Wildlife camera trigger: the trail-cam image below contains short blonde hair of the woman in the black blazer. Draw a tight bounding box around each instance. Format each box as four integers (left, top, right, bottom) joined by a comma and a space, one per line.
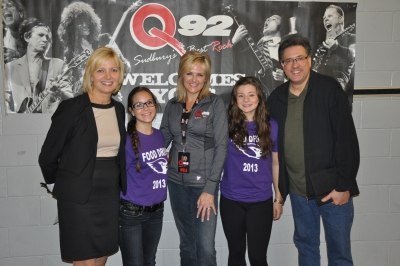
83, 47, 125, 94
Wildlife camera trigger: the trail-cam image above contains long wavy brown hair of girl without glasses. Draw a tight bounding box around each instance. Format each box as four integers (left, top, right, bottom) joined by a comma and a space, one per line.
228, 77, 272, 158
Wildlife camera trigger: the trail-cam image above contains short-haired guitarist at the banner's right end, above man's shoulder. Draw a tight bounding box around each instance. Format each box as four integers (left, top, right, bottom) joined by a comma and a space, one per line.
313, 5, 356, 97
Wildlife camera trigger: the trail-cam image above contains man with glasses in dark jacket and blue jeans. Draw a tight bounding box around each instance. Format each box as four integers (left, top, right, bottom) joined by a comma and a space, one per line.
267, 35, 360, 266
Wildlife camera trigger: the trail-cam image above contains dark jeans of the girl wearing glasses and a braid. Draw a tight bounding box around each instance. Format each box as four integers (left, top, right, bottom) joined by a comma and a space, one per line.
119, 204, 164, 266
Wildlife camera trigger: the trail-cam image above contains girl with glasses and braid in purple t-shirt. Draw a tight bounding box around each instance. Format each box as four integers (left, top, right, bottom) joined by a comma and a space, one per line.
119, 87, 168, 265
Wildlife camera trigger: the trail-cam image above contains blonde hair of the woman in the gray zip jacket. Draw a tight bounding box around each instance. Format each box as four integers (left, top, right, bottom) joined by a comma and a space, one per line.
176, 51, 211, 102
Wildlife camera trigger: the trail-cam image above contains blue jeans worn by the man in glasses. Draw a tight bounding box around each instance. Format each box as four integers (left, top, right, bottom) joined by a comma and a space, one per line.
290, 193, 354, 266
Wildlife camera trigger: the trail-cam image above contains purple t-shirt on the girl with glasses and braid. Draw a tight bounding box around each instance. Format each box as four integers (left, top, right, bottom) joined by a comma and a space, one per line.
121, 128, 168, 206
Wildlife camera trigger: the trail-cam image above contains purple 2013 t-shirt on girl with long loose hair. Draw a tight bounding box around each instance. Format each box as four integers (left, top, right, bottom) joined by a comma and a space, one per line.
221, 118, 278, 202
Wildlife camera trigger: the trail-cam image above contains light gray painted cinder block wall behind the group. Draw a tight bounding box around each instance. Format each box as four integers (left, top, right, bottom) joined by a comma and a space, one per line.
0, 0, 400, 266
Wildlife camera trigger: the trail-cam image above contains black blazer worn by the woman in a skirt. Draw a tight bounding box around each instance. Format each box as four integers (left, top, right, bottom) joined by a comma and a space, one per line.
39, 93, 126, 204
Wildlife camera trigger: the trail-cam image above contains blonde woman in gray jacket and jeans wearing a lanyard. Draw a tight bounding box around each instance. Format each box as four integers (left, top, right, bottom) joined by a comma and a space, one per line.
160, 51, 228, 266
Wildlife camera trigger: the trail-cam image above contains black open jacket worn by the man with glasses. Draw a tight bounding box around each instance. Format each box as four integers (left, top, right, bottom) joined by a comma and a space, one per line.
267, 71, 360, 199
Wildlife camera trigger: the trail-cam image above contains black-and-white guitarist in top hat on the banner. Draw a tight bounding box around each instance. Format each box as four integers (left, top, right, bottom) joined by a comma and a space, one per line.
232, 15, 285, 97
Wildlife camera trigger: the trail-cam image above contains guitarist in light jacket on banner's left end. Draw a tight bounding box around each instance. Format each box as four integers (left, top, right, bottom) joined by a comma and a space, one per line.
5, 18, 73, 113
